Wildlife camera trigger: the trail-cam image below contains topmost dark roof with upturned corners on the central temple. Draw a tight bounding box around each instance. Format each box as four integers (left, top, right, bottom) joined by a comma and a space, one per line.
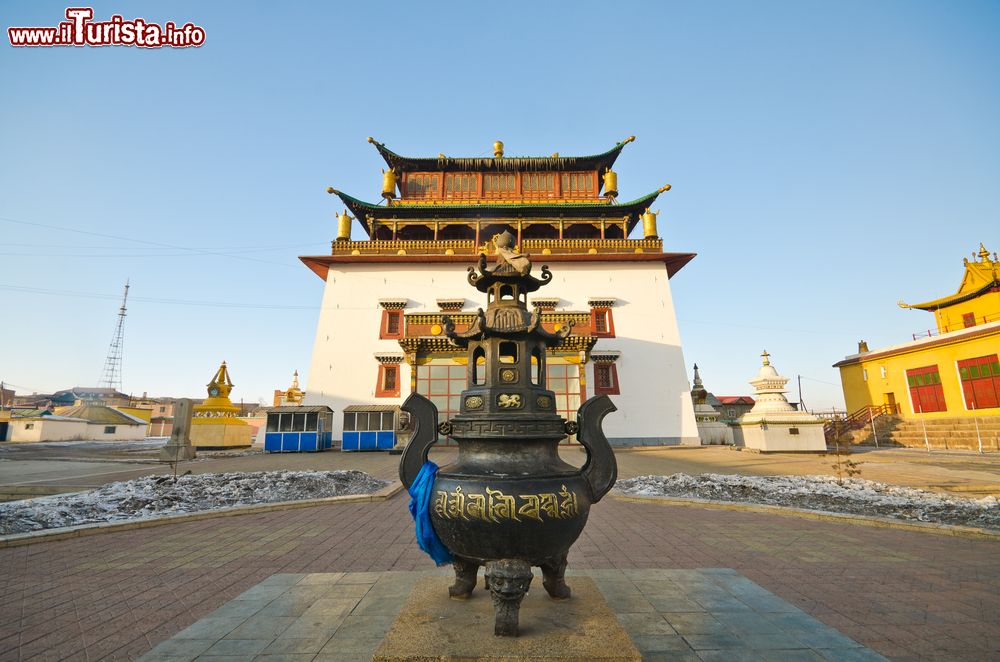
368, 136, 635, 172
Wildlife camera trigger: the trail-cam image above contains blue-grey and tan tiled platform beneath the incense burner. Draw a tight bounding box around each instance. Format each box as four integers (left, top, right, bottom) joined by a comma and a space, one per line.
140, 568, 885, 662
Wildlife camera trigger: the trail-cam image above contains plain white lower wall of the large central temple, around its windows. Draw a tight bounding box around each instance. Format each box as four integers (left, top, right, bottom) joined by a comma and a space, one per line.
305, 256, 699, 445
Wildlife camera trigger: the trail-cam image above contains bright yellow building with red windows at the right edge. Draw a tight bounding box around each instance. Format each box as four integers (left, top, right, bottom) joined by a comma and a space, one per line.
834, 244, 1000, 419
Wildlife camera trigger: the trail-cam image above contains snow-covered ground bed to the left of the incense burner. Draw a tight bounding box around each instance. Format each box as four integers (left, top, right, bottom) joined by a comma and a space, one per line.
0, 471, 389, 535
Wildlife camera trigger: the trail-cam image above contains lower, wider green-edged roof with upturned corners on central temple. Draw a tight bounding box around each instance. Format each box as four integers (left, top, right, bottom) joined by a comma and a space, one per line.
329, 186, 668, 234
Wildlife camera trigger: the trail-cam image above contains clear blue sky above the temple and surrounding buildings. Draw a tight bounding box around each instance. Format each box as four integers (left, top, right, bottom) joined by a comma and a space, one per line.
0, 0, 1000, 407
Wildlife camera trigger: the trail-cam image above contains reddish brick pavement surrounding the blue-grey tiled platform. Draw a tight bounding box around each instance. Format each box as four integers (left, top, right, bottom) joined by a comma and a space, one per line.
0, 494, 1000, 660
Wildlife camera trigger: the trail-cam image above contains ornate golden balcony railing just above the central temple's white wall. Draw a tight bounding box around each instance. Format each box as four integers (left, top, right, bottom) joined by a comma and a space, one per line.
332, 239, 663, 255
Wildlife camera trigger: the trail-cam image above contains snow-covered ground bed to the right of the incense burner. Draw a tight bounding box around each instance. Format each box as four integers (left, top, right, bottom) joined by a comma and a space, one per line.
616, 474, 1000, 529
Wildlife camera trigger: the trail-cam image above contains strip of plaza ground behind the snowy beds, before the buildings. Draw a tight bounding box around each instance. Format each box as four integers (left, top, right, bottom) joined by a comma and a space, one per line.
0, 444, 1000, 498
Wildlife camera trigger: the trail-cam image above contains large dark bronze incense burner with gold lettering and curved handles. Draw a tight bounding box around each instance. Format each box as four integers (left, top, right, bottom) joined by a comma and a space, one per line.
399, 233, 617, 636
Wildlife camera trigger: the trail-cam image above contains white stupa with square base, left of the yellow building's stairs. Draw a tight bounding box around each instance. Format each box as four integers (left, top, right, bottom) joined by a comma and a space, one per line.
737, 350, 826, 452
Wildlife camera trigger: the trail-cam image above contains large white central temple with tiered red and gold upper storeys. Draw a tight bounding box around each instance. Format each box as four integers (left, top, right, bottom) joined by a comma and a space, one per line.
301, 137, 699, 445
